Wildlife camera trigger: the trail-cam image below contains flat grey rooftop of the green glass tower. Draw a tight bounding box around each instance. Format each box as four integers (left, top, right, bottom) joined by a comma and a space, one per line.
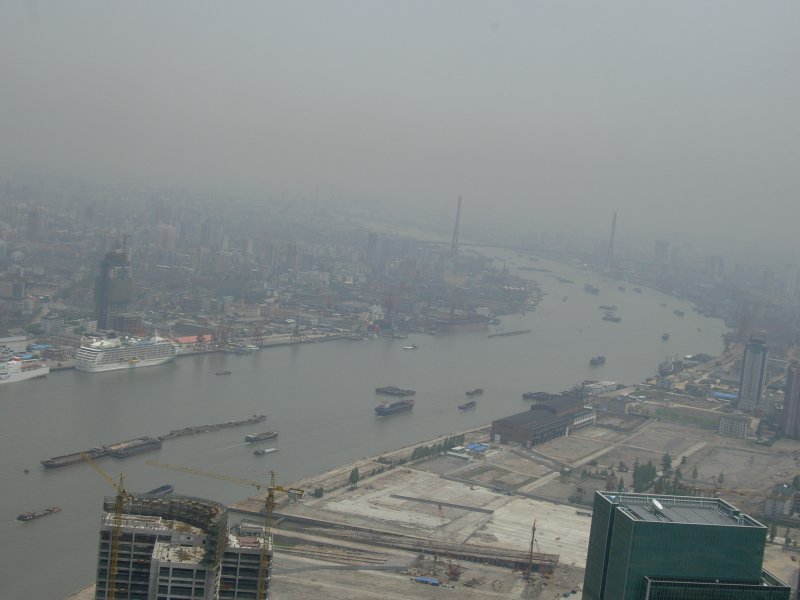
598, 492, 764, 528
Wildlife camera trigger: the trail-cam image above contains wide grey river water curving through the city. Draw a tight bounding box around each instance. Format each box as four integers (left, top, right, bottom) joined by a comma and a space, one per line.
0, 253, 725, 599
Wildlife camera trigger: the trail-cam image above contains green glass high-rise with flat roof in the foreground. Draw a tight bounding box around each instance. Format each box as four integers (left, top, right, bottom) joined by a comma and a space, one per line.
583, 491, 791, 600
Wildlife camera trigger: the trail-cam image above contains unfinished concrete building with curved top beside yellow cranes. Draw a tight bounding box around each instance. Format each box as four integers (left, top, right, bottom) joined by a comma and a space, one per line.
95, 494, 272, 600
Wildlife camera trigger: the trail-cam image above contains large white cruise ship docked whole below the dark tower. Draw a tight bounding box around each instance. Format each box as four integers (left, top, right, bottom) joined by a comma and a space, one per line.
75, 335, 179, 373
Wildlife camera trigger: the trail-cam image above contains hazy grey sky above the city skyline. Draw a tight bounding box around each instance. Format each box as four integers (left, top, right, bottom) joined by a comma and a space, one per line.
0, 0, 800, 248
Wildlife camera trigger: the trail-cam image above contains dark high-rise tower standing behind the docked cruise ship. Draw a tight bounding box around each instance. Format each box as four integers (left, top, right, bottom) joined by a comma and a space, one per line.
94, 242, 133, 329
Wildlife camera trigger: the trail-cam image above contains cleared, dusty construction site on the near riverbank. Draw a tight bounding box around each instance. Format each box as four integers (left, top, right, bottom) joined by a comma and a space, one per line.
65, 394, 800, 600
